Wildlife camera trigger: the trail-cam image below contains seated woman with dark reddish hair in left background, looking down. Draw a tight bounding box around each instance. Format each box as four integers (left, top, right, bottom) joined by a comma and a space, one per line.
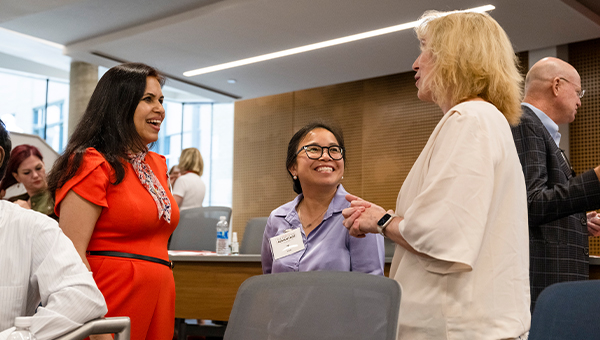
0, 144, 58, 219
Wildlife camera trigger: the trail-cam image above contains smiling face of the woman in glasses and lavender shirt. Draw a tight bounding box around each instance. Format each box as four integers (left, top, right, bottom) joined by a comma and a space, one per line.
288, 128, 344, 193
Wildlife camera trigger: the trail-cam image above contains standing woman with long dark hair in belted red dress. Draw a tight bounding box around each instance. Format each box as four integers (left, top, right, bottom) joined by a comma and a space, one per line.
49, 63, 179, 340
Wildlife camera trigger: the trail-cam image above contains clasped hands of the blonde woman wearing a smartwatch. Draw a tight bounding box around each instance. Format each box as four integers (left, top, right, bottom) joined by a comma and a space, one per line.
342, 194, 393, 238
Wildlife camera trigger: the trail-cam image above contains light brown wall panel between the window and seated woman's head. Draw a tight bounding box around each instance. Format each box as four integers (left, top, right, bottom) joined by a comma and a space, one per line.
231, 93, 295, 242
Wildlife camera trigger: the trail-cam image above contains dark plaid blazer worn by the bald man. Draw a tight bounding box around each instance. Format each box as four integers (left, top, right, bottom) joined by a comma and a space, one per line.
512, 106, 600, 311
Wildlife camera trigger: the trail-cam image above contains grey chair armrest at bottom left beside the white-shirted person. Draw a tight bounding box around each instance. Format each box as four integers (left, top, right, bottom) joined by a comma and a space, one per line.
56, 317, 131, 340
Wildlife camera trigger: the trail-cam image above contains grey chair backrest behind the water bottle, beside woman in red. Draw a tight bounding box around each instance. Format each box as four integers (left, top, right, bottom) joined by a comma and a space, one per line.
169, 207, 231, 251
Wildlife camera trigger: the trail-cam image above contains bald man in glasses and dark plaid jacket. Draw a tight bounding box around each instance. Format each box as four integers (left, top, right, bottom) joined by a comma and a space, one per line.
512, 58, 600, 311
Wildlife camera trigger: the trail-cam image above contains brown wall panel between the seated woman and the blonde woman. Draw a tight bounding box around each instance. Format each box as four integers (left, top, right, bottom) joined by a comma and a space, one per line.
362, 72, 442, 210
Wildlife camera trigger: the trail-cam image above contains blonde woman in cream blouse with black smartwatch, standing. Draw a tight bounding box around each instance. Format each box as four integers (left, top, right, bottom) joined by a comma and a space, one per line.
342, 12, 531, 340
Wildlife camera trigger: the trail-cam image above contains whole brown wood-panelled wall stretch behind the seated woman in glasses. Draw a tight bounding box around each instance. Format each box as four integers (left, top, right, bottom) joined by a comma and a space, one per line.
232, 72, 442, 237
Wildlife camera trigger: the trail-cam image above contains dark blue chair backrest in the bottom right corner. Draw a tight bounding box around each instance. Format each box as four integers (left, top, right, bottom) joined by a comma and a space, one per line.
529, 280, 600, 340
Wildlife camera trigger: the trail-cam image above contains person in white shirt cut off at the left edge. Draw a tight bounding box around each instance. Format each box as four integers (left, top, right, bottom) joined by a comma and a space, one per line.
0, 120, 107, 340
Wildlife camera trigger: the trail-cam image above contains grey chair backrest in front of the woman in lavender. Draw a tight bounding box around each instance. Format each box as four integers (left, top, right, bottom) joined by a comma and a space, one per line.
224, 271, 401, 340
